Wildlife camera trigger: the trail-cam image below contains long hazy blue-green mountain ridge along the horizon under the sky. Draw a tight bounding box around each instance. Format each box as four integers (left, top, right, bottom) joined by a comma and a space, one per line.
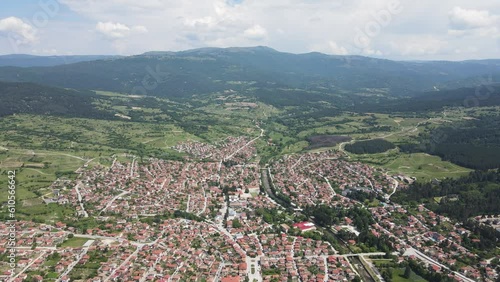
0, 47, 500, 100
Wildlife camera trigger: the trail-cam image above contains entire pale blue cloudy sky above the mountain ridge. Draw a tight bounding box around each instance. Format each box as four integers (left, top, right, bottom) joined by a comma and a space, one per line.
0, 0, 500, 60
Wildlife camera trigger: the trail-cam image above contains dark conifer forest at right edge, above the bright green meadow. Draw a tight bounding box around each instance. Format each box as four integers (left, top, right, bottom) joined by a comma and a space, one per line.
399, 115, 500, 169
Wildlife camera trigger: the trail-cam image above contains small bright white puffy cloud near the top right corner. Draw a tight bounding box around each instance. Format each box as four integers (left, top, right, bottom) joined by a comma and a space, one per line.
449, 7, 499, 30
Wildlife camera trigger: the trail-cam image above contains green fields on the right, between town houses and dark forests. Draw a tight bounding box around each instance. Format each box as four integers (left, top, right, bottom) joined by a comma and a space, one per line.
267, 111, 471, 181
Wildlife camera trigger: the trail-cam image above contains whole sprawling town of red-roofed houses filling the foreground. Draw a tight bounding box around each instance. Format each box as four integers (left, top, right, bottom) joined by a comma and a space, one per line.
0, 137, 499, 282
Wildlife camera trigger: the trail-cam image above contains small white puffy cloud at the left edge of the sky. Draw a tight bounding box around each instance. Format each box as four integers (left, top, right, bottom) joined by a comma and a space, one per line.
0, 17, 37, 45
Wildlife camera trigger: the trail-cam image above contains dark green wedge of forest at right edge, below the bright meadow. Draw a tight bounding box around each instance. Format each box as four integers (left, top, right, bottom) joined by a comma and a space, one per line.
392, 169, 500, 221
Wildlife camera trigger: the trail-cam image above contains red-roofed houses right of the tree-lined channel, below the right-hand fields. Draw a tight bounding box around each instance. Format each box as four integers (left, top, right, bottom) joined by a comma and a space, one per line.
271, 151, 392, 206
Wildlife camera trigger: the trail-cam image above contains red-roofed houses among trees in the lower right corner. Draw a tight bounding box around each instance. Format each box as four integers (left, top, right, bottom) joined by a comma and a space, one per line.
370, 205, 498, 281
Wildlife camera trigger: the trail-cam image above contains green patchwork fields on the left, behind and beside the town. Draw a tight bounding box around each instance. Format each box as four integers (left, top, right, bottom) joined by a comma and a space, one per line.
0, 92, 270, 222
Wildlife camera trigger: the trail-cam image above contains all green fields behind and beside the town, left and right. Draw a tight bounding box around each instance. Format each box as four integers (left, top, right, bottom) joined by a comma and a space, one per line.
0, 94, 484, 225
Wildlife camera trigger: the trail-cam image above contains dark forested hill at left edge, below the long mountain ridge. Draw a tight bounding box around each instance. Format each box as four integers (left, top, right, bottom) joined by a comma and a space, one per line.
0, 82, 112, 118
